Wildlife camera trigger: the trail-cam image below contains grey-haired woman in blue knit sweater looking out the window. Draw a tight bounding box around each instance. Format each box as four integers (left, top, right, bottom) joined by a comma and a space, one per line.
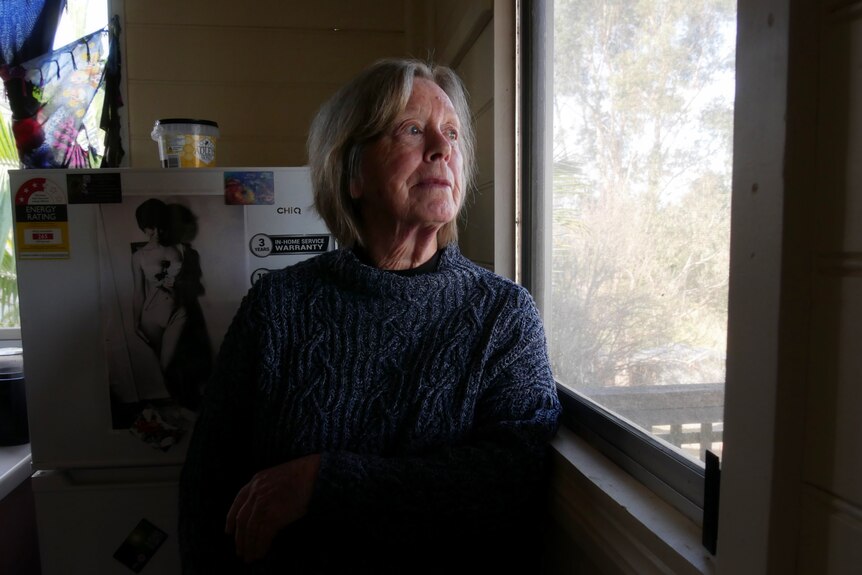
180, 60, 559, 573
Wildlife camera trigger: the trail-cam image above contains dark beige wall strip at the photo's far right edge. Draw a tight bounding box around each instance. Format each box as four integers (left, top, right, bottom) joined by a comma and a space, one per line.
794, 2, 862, 573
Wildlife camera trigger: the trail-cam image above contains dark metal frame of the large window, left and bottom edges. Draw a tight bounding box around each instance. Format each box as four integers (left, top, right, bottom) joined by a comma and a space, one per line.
517, 0, 706, 527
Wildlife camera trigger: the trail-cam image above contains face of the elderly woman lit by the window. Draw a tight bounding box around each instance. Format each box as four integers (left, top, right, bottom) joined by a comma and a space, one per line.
351, 78, 462, 236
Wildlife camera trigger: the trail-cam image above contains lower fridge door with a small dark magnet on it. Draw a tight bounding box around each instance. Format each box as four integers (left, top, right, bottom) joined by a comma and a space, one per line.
31, 468, 181, 575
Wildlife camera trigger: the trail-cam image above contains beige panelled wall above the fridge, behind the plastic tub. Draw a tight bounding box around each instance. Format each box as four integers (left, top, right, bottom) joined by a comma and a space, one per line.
123, 0, 422, 168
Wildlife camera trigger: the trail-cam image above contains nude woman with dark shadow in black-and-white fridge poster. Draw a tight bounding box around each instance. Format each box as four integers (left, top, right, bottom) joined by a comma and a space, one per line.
128, 198, 212, 449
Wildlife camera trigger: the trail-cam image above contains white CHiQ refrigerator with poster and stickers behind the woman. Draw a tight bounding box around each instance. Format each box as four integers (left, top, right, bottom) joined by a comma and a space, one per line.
10, 167, 336, 575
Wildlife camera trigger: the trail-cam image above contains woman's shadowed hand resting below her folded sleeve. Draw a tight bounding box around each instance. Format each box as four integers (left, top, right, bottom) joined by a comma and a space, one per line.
225, 454, 320, 562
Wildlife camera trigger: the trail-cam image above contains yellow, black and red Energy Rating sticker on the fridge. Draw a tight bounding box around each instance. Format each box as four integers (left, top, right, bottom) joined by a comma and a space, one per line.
15, 178, 69, 259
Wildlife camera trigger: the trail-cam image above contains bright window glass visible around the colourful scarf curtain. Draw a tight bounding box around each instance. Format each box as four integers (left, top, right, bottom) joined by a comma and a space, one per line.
0, 0, 108, 339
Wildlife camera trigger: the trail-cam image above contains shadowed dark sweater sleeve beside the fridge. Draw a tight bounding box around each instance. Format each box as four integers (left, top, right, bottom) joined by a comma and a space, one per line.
179, 291, 263, 575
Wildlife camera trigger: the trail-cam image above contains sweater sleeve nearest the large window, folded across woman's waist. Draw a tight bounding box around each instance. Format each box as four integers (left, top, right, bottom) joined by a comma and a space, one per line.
311, 292, 560, 545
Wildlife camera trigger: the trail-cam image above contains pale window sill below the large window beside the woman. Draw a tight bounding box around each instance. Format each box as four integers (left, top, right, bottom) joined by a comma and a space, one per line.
550, 428, 715, 575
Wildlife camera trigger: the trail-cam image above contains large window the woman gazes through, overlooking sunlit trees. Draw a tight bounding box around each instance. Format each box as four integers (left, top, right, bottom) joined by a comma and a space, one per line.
520, 0, 736, 520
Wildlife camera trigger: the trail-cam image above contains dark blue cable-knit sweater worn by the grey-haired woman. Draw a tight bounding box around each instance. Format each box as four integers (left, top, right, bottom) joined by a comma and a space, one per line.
180, 245, 559, 575
